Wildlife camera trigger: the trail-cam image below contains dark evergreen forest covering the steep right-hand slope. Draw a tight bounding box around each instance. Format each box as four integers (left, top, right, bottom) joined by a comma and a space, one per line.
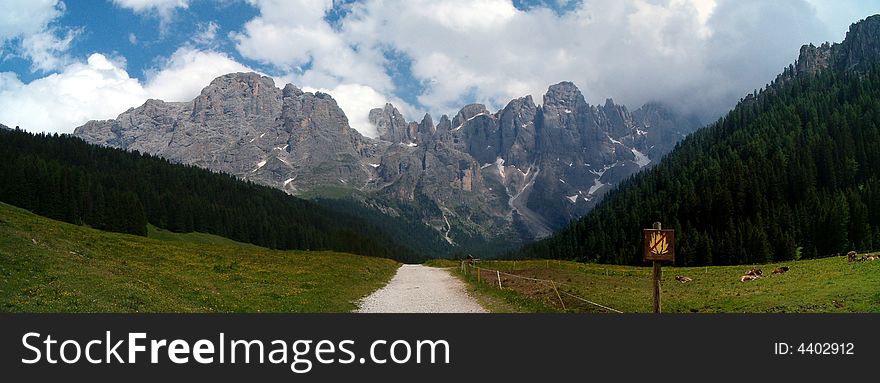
510, 63, 880, 265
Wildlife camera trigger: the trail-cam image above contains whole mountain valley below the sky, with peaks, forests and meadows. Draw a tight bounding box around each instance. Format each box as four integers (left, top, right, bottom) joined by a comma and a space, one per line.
0, 4, 880, 313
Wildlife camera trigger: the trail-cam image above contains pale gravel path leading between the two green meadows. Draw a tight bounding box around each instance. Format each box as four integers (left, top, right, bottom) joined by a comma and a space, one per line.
357, 265, 487, 313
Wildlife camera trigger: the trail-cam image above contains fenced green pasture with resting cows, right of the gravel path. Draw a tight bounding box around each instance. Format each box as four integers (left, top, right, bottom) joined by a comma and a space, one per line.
436, 257, 880, 313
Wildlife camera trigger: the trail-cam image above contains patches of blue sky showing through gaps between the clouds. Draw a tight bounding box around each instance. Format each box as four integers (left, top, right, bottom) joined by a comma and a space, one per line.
2, 0, 577, 105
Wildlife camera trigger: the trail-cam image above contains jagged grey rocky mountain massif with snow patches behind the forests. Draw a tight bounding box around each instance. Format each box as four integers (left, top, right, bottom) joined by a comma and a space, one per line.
74, 73, 698, 252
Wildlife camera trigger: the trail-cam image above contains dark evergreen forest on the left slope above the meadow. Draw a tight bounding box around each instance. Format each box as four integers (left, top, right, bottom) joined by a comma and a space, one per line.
0, 129, 422, 261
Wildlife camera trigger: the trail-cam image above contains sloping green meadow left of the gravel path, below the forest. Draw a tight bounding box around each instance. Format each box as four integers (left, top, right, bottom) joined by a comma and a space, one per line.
0, 203, 398, 312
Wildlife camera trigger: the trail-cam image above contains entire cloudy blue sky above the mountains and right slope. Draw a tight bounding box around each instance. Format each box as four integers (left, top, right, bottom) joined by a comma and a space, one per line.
0, 0, 880, 136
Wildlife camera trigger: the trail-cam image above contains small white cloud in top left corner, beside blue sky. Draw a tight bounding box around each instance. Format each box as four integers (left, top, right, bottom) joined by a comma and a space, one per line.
0, 0, 80, 71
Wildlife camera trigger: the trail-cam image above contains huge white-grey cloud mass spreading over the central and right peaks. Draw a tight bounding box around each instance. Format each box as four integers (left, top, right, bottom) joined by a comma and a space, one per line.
231, 0, 876, 126
